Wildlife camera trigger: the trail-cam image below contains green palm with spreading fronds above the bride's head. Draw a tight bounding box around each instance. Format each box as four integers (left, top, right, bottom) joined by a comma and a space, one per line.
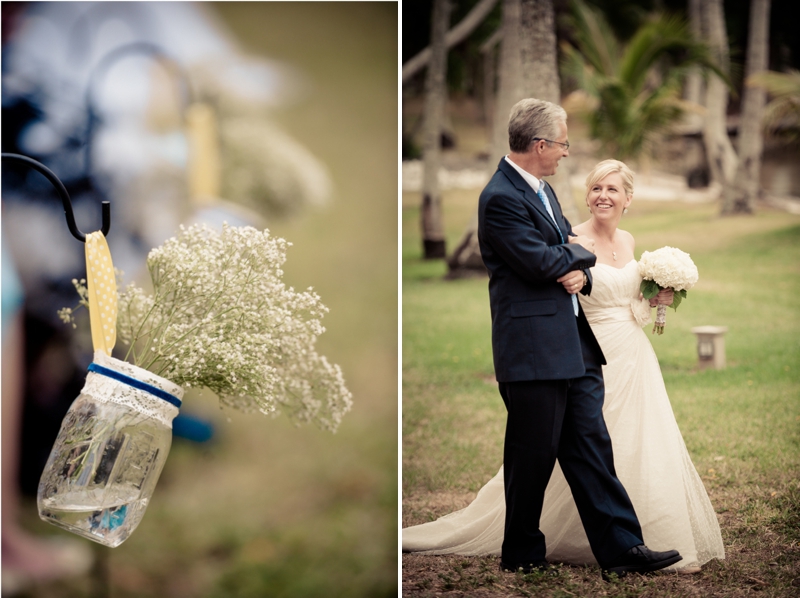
562, 0, 727, 159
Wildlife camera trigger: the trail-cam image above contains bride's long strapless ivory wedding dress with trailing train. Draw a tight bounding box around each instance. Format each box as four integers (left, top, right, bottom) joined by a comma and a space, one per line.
403, 260, 725, 569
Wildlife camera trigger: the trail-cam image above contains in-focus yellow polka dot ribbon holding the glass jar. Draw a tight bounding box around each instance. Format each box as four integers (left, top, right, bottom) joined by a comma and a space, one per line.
86, 231, 117, 355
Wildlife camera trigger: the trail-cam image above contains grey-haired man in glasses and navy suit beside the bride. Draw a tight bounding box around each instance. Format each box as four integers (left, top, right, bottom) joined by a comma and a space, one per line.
478, 99, 681, 575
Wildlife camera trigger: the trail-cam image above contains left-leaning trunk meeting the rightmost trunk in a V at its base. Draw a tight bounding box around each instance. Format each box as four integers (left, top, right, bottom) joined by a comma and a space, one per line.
701, 0, 737, 186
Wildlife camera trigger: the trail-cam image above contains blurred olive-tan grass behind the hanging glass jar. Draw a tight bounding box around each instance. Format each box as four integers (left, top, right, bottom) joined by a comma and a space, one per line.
12, 2, 398, 598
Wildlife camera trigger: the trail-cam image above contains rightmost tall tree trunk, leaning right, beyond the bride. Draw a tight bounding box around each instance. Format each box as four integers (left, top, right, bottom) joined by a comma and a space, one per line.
722, 0, 770, 215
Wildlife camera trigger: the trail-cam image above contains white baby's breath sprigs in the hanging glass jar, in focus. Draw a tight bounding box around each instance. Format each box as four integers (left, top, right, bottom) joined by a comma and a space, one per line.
60, 224, 352, 431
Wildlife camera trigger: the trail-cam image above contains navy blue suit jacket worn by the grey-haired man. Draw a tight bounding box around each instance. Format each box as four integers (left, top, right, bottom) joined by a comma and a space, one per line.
478, 159, 605, 382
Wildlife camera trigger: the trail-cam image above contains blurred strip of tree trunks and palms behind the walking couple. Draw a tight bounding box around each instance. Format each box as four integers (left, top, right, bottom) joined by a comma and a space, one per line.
402, 0, 800, 266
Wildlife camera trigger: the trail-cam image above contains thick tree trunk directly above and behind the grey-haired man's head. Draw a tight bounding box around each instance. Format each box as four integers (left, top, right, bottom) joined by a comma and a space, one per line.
520, 0, 580, 224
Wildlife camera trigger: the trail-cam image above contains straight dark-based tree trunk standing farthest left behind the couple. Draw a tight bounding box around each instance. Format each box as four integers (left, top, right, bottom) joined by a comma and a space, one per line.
420, 0, 450, 259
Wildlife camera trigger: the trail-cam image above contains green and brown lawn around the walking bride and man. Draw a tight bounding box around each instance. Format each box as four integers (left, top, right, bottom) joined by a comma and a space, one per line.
402, 191, 800, 596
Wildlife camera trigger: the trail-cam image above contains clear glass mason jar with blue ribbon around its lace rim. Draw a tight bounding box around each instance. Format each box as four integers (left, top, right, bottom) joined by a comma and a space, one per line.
37, 351, 183, 547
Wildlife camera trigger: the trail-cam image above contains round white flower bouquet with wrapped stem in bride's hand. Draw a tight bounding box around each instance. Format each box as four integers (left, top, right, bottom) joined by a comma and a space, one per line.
639, 247, 698, 334
